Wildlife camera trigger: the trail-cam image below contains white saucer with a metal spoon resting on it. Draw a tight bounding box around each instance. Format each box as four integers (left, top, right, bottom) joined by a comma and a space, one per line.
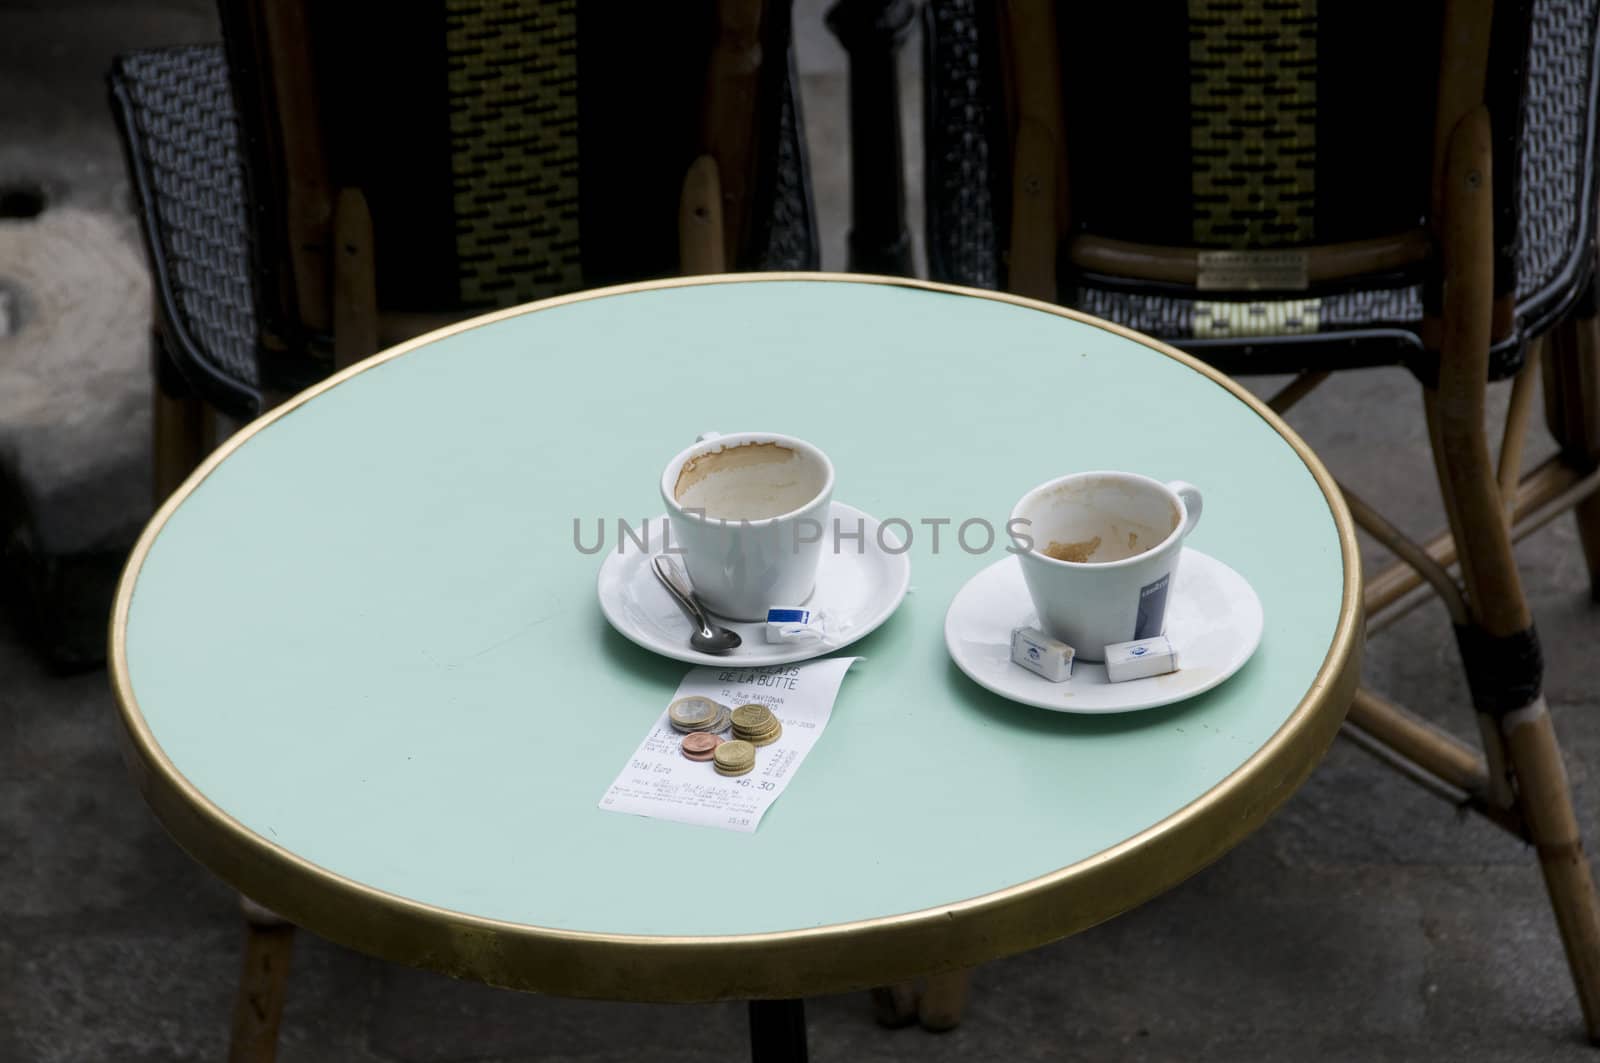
598, 503, 910, 668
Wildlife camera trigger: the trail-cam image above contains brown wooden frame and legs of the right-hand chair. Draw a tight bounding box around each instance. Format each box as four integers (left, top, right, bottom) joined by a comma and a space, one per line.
875, 0, 1600, 1044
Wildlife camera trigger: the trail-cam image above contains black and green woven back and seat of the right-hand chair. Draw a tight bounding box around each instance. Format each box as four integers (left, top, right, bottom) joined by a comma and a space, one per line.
925, 0, 1600, 382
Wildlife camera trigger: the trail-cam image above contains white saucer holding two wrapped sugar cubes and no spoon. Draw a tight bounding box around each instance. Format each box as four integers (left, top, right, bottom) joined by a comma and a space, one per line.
944, 548, 1262, 712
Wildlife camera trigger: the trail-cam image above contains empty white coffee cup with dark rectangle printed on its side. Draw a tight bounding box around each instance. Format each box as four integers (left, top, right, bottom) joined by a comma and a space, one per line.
1008, 472, 1202, 661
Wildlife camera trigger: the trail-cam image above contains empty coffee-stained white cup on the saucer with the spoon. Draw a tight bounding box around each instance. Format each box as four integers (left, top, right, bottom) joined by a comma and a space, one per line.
661, 432, 834, 620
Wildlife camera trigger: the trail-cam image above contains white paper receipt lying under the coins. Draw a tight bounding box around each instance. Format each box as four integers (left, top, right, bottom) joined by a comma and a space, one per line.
600, 656, 861, 832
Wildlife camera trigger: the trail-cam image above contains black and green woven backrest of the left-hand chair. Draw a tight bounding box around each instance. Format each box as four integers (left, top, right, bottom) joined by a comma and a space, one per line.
221, 0, 816, 398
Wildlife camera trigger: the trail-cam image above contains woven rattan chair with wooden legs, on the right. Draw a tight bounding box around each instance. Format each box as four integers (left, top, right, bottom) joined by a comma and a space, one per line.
891, 0, 1600, 1041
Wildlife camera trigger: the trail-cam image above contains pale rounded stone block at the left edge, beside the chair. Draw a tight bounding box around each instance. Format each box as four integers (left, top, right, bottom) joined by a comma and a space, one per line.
0, 202, 150, 668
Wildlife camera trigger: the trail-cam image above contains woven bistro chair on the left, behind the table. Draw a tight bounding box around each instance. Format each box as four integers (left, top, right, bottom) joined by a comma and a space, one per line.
109, 0, 818, 1060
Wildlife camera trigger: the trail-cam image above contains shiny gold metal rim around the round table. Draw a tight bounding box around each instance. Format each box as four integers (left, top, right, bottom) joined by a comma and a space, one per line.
109, 272, 1363, 1002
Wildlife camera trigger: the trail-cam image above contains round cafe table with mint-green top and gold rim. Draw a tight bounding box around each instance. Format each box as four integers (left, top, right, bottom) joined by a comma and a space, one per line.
110, 274, 1360, 1055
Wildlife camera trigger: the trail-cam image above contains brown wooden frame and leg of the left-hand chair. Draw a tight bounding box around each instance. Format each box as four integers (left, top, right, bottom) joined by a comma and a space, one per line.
144, 0, 766, 1063
